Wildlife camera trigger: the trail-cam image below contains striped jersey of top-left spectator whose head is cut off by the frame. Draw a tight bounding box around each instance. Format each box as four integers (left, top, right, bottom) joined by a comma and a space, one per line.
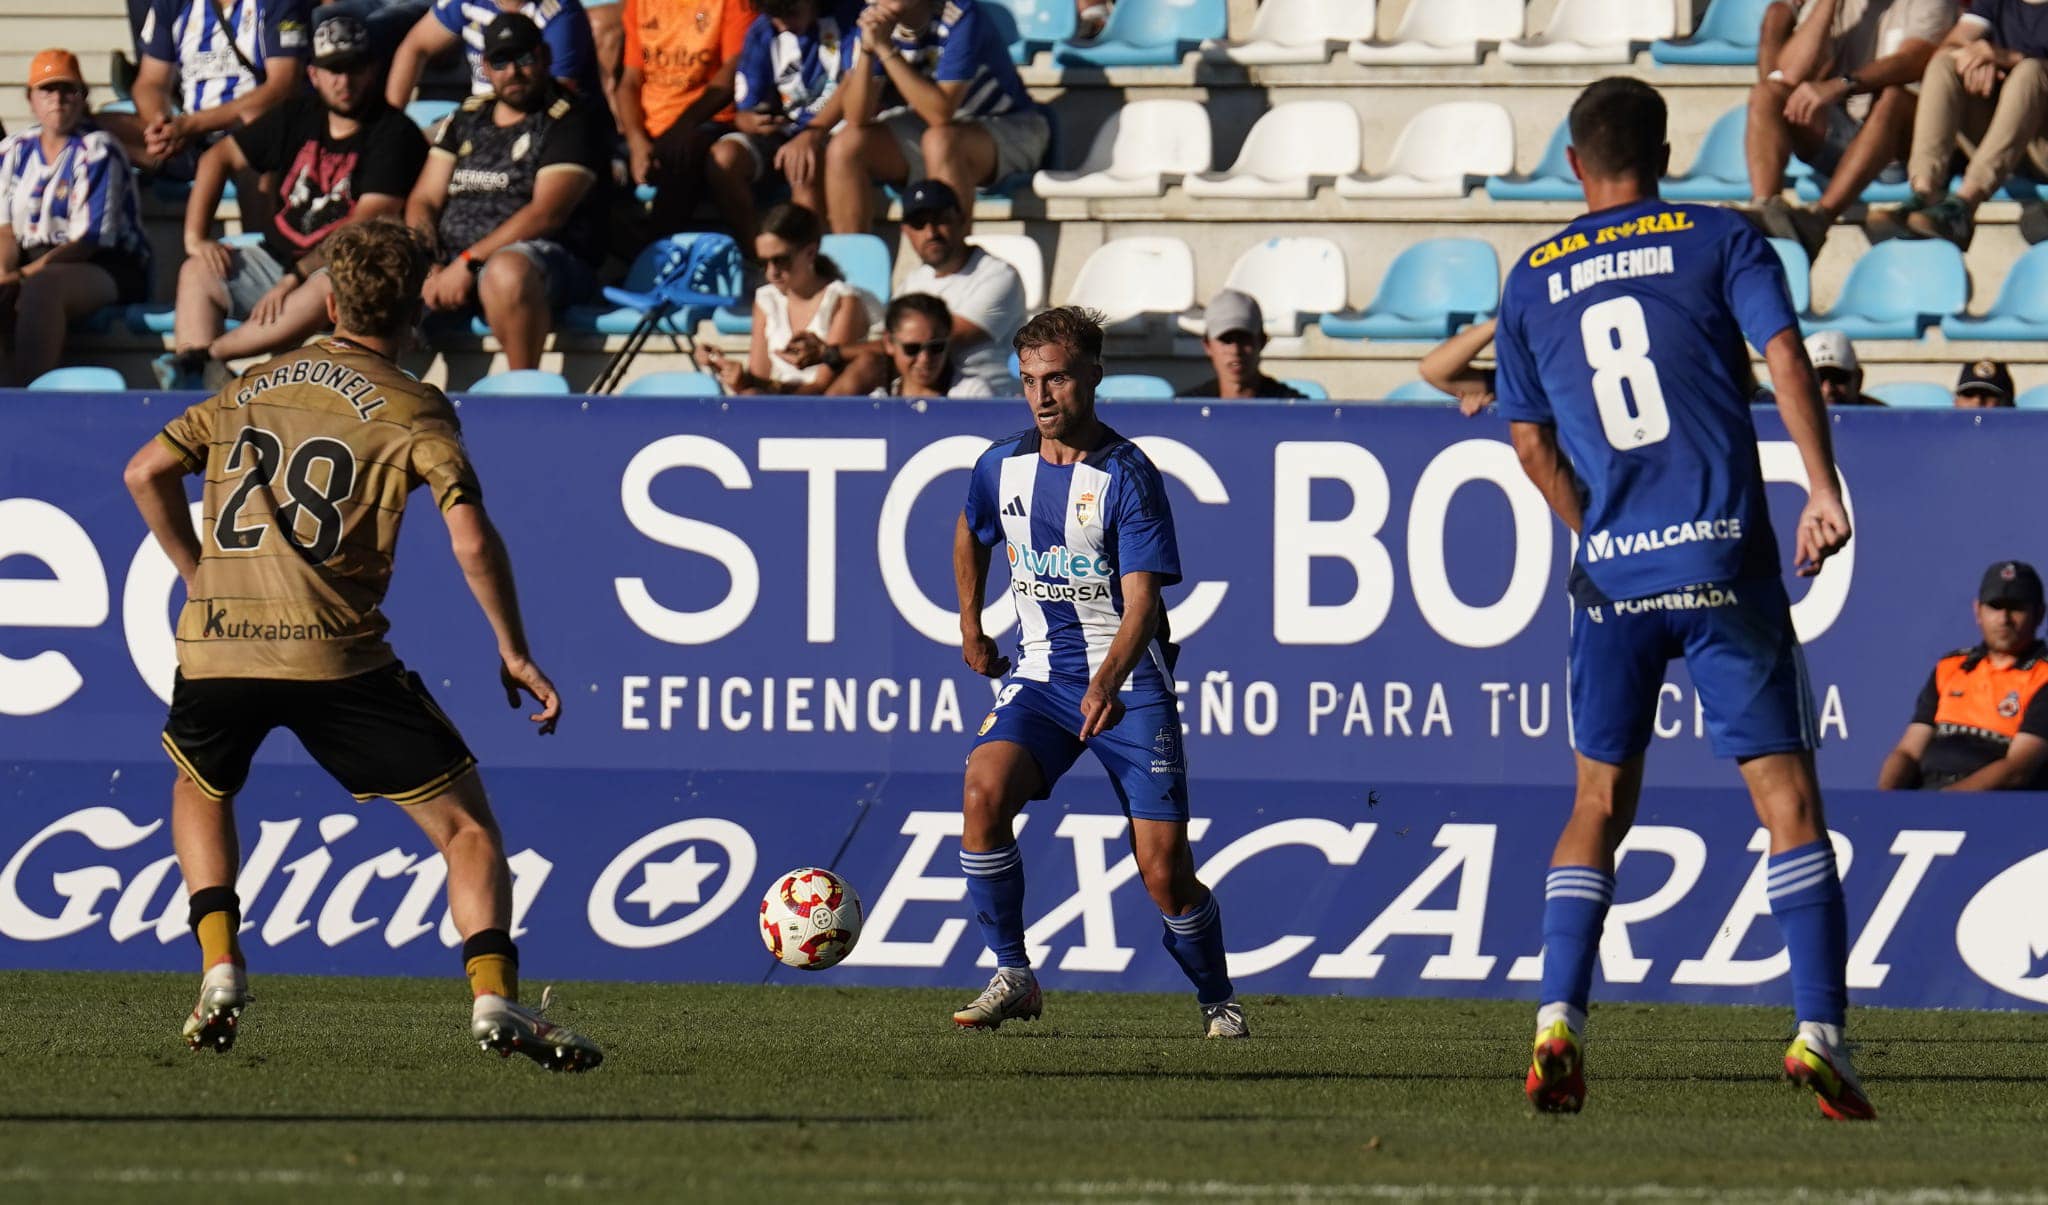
141, 0, 313, 113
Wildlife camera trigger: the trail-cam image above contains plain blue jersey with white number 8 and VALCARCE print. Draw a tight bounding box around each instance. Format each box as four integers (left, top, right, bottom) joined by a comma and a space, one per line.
1495, 199, 1798, 603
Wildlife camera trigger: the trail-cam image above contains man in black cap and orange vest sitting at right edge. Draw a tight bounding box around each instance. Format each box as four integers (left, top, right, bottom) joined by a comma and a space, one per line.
1878, 562, 2048, 791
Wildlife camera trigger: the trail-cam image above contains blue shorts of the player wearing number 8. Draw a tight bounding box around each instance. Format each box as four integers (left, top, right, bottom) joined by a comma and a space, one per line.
1569, 578, 1821, 764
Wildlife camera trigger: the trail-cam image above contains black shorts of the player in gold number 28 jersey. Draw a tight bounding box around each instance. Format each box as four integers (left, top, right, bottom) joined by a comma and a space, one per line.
164, 662, 477, 803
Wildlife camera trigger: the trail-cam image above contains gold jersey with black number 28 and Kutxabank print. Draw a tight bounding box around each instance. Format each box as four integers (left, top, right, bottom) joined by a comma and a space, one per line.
158, 338, 481, 680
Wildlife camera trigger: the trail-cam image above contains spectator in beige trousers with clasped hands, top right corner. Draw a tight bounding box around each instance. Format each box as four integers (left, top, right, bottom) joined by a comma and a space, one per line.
1870, 0, 2048, 250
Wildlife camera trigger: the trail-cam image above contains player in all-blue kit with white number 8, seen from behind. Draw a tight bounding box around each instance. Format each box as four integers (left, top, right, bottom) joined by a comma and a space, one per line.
1495, 78, 1874, 1119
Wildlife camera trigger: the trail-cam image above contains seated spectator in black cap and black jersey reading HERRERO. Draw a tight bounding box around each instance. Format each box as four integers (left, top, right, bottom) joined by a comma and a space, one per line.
406, 12, 612, 369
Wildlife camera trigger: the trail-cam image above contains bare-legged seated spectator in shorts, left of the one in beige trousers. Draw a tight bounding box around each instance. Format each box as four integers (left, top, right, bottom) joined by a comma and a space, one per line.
1745, 0, 1956, 256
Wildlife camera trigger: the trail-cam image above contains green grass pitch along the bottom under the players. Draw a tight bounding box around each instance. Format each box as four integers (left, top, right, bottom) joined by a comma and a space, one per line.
0, 971, 2048, 1205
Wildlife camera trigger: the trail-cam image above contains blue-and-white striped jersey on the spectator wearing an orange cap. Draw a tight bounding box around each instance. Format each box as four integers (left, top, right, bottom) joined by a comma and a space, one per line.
0, 121, 150, 264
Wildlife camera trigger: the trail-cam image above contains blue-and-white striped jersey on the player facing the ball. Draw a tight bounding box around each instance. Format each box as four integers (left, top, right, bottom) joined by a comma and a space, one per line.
967, 430, 1180, 707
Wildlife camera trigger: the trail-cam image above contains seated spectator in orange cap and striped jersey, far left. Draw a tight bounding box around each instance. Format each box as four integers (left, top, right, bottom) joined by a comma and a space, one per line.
0, 49, 150, 385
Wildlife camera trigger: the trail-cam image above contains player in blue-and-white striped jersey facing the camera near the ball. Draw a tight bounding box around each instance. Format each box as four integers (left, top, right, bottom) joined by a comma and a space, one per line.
952, 307, 1249, 1037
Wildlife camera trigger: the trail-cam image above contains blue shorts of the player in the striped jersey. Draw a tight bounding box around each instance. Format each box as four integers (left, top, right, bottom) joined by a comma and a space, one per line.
975, 678, 1188, 822
